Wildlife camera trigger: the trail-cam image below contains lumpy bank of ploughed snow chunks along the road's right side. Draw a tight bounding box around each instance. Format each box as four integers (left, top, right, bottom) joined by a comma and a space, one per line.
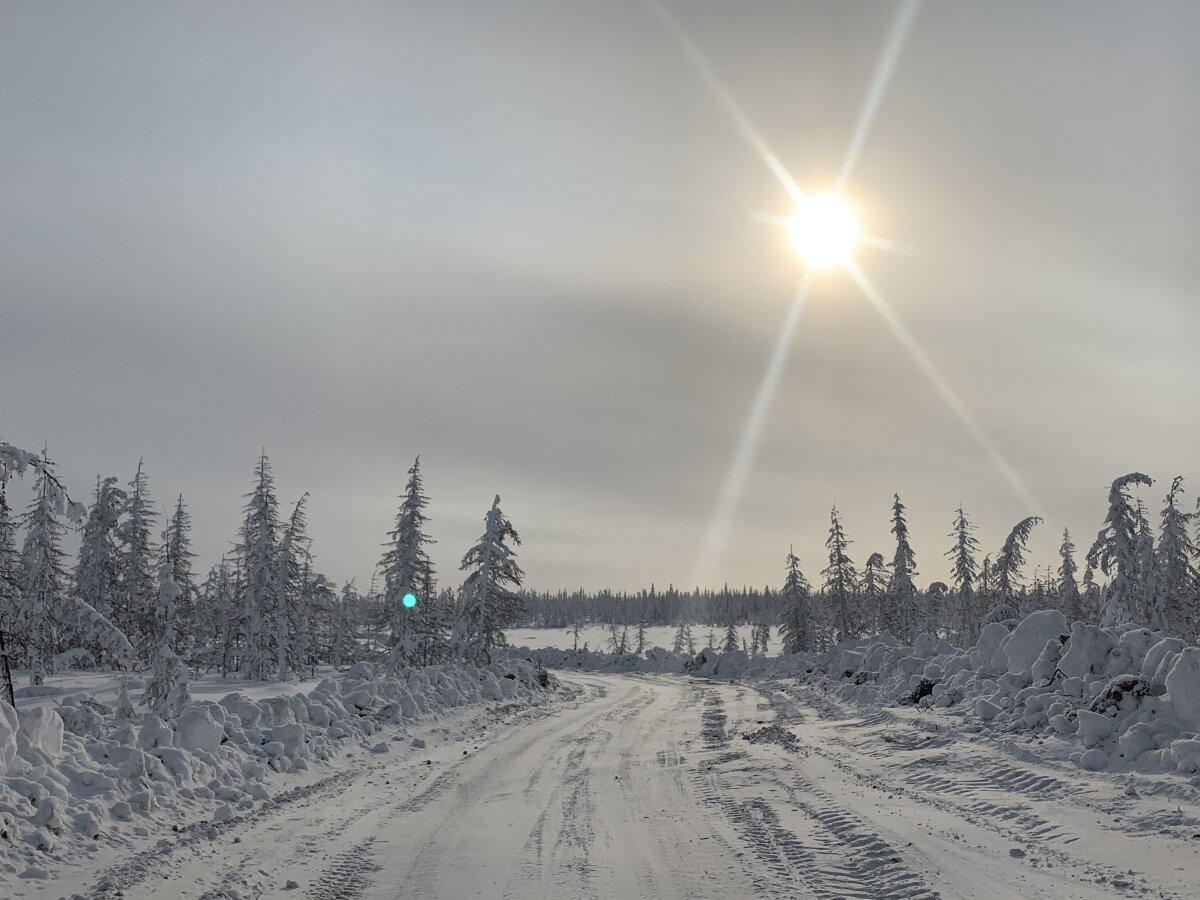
801, 610, 1200, 785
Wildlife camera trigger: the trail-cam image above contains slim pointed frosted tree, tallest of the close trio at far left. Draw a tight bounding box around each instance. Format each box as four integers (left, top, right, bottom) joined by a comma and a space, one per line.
113, 460, 157, 655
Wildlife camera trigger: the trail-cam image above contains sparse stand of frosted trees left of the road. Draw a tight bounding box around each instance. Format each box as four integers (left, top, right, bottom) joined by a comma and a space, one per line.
0, 444, 523, 716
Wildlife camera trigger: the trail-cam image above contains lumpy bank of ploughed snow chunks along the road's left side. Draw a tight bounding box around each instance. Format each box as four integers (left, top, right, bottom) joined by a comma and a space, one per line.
0, 660, 556, 893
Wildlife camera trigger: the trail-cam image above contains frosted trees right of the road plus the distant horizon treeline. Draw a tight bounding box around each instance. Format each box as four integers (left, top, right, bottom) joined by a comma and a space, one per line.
520, 473, 1200, 652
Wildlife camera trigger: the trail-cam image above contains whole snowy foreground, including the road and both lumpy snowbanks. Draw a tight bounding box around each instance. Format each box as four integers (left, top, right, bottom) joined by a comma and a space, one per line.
9, 611, 1200, 900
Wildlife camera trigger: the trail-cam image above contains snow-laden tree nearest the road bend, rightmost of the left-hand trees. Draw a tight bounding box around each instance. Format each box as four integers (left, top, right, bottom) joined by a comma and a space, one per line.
452, 494, 524, 662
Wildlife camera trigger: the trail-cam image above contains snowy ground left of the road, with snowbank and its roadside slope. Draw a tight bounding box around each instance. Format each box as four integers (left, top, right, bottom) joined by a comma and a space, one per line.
0, 660, 558, 898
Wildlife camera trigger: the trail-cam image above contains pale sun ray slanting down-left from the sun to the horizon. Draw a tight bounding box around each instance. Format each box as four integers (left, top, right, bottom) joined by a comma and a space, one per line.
695, 269, 812, 586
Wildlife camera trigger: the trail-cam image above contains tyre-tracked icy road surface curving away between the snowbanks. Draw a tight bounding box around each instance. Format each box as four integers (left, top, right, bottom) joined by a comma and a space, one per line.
88, 672, 1200, 900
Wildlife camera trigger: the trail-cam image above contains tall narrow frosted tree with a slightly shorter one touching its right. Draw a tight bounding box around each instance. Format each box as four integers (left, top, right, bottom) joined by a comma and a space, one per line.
238, 452, 280, 682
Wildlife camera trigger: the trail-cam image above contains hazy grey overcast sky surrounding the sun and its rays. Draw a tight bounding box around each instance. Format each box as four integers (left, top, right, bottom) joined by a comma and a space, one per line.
0, 0, 1200, 600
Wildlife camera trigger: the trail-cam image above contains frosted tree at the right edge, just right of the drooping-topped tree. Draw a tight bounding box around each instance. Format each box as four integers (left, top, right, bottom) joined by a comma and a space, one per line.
1146, 476, 1200, 642
